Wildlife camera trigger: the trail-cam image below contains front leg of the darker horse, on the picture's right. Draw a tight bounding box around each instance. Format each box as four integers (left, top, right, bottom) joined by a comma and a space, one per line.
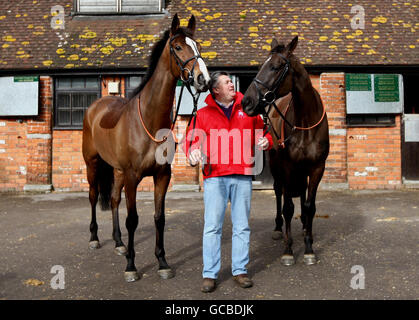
302, 164, 324, 265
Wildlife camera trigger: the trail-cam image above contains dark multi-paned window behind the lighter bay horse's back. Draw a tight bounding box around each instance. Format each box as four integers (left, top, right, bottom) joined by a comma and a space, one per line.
54, 77, 100, 129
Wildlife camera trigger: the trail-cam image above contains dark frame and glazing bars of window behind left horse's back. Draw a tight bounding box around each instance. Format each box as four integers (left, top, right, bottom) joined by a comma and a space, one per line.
53, 76, 102, 130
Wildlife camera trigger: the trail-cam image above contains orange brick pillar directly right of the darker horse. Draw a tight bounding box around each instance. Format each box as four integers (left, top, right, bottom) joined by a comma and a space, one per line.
319, 73, 348, 189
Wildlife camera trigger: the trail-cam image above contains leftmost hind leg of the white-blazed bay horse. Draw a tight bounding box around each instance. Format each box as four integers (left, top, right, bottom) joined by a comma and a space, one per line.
86, 158, 100, 249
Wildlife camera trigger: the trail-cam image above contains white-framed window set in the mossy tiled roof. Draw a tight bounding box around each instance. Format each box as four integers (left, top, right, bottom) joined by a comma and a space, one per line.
75, 0, 163, 14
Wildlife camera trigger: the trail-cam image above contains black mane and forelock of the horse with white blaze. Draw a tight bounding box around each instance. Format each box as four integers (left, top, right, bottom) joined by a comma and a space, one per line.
129, 28, 192, 99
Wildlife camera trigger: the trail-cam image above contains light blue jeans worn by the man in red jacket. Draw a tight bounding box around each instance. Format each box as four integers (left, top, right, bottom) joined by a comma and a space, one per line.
202, 175, 252, 279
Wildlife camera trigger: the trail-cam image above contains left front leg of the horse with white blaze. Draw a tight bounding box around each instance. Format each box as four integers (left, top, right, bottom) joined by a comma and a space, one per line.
124, 173, 140, 282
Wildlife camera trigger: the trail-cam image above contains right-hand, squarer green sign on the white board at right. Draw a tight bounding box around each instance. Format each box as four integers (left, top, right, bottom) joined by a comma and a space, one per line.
374, 74, 400, 102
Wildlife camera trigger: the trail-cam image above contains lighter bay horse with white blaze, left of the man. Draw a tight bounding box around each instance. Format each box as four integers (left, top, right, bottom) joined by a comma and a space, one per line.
82, 14, 210, 282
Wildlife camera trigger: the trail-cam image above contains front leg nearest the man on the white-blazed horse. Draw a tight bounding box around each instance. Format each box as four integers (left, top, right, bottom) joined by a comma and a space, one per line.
153, 165, 174, 279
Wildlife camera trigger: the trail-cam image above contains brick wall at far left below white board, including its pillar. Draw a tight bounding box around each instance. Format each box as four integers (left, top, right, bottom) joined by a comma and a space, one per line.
0, 76, 53, 191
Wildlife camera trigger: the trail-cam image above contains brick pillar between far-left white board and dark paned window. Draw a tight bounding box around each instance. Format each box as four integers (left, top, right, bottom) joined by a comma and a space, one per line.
23, 76, 53, 191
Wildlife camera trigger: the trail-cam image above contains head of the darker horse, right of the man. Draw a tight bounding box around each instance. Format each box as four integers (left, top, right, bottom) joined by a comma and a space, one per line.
242, 37, 298, 116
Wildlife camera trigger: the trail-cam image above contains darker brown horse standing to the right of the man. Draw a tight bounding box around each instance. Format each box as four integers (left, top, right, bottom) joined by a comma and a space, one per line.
242, 37, 329, 265
